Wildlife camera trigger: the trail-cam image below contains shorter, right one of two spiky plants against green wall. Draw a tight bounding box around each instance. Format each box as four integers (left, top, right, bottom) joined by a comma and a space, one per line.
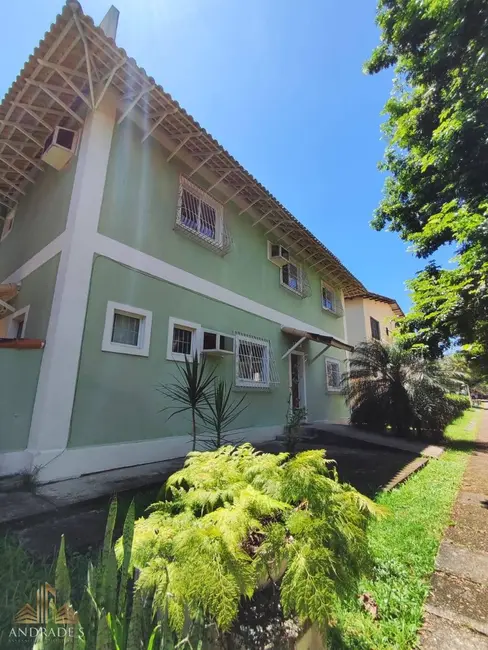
200, 378, 248, 449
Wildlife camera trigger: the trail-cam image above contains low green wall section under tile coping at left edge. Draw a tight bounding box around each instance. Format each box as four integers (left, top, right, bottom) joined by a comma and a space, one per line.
0, 350, 42, 453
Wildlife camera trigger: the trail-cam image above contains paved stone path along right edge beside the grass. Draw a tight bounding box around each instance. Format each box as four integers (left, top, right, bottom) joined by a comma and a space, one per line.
420, 410, 488, 650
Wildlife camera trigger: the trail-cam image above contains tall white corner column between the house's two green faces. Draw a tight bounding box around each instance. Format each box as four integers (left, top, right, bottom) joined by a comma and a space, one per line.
28, 93, 116, 466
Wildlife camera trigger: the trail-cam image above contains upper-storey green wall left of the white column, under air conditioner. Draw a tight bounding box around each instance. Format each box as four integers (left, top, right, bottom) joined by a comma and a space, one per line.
0, 158, 76, 282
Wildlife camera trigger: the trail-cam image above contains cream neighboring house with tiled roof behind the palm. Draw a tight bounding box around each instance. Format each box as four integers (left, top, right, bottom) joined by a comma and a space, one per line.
346, 291, 404, 345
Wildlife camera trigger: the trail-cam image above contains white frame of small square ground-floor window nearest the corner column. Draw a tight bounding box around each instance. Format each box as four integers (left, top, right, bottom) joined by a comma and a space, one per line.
102, 300, 152, 357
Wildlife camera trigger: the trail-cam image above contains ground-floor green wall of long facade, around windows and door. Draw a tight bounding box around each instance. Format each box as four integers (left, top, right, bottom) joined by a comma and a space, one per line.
69, 257, 347, 447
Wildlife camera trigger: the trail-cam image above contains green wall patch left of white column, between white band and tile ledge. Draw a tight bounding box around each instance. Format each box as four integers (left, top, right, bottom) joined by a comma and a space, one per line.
2, 255, 59, 339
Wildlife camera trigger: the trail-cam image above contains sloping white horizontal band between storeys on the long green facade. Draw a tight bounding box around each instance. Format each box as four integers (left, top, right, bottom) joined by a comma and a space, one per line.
95, 233, 346, 343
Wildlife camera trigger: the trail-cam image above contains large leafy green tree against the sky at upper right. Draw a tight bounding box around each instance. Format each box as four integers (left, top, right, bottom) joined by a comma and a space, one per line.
366, 0, 488, 368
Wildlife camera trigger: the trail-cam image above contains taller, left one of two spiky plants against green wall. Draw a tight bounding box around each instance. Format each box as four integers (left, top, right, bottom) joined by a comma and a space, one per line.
158, 352, 215, 451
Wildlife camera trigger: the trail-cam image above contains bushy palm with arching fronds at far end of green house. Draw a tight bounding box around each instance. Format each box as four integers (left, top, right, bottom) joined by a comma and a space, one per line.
342, 340, 453, 437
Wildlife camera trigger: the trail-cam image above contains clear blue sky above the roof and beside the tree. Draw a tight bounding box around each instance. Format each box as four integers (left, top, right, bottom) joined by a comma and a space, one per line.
0, 0, 454, 309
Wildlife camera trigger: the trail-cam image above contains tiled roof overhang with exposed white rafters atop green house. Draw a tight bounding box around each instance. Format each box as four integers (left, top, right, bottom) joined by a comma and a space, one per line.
0, 0, 366, 296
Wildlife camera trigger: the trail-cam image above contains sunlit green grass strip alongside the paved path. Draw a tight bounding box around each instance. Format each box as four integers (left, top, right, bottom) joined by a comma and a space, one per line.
330, 409, 481, 650
